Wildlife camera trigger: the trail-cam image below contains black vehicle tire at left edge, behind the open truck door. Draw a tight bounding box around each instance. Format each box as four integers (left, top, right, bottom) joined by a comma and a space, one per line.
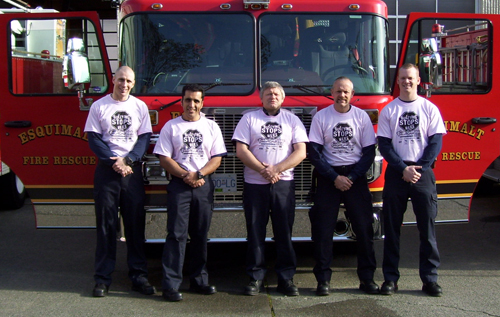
0, 171, 26, 210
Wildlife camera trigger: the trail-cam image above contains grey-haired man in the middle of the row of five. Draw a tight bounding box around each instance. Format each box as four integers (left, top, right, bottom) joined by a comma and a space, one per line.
233, 82, 308, 296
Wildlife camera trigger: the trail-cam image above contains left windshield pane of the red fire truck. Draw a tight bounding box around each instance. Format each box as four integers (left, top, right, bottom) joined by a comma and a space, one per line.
121, 13, 255, 95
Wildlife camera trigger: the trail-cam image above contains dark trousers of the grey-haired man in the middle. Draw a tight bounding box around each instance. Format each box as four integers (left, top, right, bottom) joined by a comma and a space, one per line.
243, 181, 297, 281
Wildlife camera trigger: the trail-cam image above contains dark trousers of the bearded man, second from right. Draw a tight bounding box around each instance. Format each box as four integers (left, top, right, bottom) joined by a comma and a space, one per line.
309, 170, 377, 283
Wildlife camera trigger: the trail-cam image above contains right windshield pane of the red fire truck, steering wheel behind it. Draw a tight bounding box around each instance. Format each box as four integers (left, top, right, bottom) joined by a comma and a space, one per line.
260, 13, 389, 95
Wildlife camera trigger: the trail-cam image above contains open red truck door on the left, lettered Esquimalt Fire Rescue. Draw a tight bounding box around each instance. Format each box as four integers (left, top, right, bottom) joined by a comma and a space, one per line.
0, 12, 111, 227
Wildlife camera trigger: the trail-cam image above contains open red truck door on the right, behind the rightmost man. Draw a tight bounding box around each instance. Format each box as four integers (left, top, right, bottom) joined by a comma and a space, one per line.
393, 13, 500, 221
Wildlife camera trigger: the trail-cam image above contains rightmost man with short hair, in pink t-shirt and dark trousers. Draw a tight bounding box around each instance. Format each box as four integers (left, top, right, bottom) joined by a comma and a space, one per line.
377, 64, 446, 296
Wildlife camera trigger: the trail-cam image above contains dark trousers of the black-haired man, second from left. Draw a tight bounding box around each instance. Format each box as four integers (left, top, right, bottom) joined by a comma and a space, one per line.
162, 176, 214, 290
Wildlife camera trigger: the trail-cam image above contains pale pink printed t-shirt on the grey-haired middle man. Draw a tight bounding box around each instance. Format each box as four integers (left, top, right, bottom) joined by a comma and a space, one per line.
233, 108, 309, 184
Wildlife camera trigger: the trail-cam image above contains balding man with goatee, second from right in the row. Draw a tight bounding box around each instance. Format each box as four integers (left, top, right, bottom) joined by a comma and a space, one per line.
309, 77, 379, 296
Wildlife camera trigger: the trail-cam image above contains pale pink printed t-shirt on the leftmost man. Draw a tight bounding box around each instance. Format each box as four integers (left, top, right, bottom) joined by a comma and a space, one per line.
85, 95, 153, 157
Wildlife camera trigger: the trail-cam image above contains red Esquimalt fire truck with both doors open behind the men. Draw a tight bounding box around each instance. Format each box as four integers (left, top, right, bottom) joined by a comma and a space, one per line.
0, 0, 500, 242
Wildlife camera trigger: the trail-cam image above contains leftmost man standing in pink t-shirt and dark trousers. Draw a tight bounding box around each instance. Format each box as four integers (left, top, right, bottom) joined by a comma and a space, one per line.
85, 66, 156, 297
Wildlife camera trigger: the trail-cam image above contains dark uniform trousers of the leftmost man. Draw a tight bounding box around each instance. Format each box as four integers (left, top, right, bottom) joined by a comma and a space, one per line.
94, 164, 147, 285
